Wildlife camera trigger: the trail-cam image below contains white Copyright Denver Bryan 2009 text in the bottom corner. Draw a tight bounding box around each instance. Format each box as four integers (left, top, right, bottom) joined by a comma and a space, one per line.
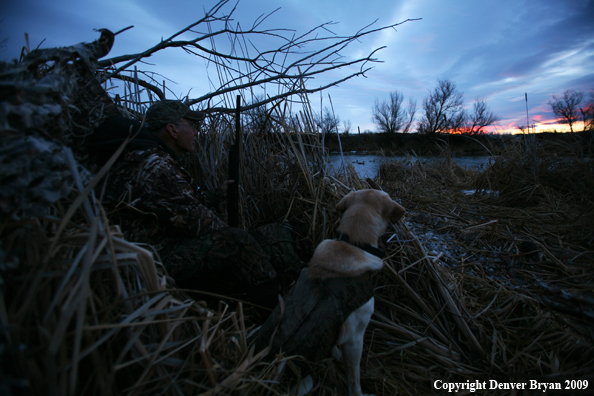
433, 380, 588, 393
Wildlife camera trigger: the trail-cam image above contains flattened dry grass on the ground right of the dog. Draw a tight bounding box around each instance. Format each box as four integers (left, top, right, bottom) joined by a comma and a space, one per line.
367, 144, 594, 395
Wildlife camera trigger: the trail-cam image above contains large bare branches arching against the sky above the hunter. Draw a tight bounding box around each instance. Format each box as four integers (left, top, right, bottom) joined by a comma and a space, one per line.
99, 0, 416, 113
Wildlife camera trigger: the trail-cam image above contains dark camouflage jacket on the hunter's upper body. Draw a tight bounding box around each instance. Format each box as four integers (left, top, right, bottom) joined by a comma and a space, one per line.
107, 146, 228, 242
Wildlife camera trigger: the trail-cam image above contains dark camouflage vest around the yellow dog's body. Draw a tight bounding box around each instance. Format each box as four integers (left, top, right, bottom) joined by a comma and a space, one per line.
255, 268, 373, 361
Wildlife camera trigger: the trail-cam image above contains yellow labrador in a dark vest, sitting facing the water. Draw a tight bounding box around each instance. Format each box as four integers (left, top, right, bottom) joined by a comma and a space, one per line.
255, 190, 405, 396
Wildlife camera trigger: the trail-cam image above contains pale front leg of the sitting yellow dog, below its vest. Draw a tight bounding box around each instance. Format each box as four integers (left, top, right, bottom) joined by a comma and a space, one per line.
336, 297, 374, 396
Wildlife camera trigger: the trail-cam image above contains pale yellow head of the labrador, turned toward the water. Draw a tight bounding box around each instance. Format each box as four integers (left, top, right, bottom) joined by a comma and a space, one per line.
336, 190, 406, 238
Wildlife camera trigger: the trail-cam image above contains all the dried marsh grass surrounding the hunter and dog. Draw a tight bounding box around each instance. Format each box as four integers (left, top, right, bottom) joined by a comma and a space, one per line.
5, 126, 594, 395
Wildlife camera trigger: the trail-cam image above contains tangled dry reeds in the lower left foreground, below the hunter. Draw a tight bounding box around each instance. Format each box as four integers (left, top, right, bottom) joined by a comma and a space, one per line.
0, 163, 286, 395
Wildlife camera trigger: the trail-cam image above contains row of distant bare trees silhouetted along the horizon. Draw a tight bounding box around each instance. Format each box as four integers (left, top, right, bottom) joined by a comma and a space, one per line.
240, 79, 594, 135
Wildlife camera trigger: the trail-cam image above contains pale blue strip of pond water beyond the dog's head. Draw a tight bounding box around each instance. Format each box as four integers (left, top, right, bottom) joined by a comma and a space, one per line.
328, 153, 492, 179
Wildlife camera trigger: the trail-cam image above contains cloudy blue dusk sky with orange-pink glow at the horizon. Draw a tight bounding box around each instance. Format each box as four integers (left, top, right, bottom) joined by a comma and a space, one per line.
0, 0, 594, 133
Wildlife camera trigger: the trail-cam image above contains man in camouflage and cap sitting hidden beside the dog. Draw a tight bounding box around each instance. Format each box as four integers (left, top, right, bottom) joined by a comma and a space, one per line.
96, 100, 301, 307
